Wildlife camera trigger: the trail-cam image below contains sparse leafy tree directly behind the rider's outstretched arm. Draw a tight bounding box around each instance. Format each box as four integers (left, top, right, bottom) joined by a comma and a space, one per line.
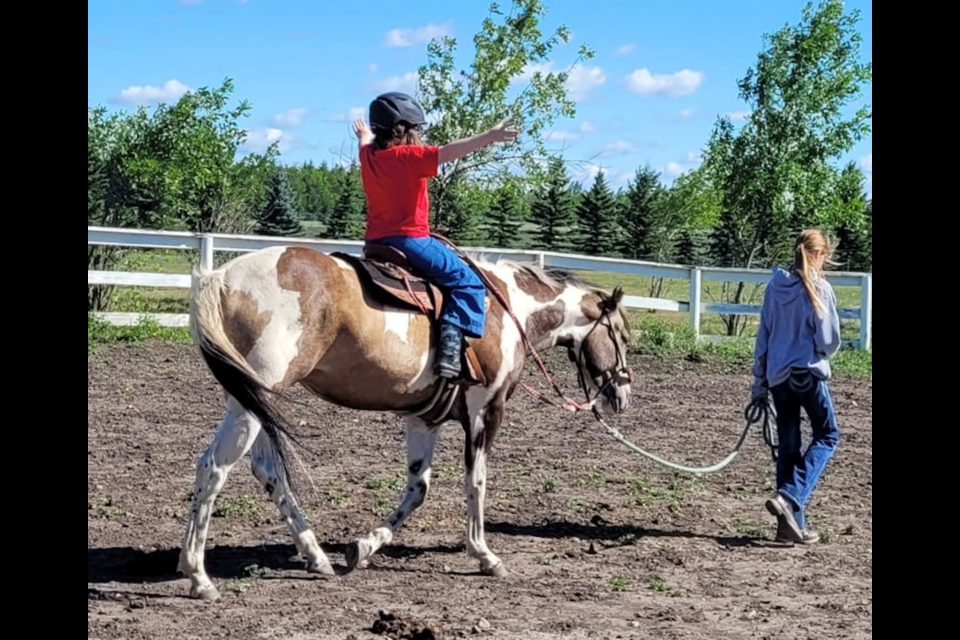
418, 0, 593, 234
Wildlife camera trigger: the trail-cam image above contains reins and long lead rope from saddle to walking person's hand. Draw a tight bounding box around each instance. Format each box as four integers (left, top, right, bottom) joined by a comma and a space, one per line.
431, 233, 777, 475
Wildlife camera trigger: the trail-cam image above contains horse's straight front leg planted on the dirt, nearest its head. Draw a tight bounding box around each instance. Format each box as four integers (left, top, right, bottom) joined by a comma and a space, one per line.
463, 389, 507, 578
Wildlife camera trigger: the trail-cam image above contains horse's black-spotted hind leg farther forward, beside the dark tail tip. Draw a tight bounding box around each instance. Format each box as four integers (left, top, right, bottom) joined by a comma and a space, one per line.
251, 431, 334, 575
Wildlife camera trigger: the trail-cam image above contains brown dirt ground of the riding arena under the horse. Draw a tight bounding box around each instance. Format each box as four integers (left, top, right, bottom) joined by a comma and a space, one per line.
87, 342, 873, 640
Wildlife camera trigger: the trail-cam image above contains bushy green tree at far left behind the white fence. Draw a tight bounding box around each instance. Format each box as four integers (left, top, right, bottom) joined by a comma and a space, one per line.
87, 78, 277, 310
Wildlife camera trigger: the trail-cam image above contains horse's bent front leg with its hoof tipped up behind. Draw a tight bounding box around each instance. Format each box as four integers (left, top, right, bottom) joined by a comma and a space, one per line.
346, 418, 439, 571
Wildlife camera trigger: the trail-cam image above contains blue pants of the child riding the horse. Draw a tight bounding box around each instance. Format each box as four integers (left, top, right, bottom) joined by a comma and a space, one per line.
369, 236, 487, 338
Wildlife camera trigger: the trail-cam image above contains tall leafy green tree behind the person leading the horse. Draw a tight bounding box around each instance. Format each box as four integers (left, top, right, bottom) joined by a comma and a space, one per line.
692, 0, 873, 335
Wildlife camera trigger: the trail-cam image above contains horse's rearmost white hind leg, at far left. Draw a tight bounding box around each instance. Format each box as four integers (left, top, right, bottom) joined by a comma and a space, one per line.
178, 397, 260, 600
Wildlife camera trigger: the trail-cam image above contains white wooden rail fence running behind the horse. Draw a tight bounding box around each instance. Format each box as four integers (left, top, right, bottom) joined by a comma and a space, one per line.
87, 226, 873, 350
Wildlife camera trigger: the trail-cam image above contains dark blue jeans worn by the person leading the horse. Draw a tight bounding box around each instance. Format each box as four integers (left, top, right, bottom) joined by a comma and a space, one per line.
770, 371, 840, 529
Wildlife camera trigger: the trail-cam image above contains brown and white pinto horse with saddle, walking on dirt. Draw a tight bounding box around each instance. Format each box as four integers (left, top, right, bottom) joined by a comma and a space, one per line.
177, 243, 631, 600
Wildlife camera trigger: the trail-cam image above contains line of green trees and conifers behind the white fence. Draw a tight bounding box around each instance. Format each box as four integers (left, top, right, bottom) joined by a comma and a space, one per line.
87, 0, 873, 336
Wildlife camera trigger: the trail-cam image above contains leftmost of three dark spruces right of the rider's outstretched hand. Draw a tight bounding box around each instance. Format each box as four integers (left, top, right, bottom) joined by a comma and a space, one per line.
531, 157, 577, 252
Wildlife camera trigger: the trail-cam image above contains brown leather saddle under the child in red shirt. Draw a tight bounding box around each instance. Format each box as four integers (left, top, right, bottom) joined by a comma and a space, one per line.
331, 242, 486, 385
